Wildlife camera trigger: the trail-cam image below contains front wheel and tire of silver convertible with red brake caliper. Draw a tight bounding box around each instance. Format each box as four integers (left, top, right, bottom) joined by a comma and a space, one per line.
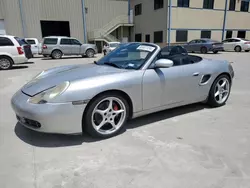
82, 93, 129, 138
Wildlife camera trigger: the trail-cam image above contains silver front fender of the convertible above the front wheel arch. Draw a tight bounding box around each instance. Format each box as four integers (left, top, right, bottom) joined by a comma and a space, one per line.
54, 70, 144, 112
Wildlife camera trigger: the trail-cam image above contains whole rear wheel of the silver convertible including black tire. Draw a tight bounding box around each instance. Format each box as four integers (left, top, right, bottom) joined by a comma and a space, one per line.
207, 74, 231, 107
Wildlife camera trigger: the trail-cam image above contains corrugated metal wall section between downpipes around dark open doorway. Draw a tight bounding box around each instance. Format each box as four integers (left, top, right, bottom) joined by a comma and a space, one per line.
23, 0, 84, 41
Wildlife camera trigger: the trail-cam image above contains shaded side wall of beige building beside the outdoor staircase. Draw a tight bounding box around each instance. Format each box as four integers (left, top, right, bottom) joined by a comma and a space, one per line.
131, 0, 168, 43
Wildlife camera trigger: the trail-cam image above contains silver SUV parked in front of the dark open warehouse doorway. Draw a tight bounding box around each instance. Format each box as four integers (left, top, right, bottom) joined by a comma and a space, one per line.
42, 36, 97, 59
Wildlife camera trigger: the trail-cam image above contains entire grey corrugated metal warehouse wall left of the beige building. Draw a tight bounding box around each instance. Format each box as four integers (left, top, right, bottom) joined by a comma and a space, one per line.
0, 0, 128, 41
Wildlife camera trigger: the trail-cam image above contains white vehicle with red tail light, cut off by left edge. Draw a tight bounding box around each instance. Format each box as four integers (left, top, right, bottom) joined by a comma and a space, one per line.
0, 35, 32, 70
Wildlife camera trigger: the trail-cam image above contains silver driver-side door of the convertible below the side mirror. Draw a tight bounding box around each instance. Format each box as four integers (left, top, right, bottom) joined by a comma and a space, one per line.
143, 55, 204, 110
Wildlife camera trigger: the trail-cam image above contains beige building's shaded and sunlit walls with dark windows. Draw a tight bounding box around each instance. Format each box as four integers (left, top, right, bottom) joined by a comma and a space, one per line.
131, 0, 250, 43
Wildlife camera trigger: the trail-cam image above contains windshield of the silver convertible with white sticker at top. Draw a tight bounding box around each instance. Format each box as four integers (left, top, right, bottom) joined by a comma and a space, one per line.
96, 43, 156, 69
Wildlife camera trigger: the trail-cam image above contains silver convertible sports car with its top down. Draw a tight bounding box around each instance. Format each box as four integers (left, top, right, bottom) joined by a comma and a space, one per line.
11, 43, 234, 138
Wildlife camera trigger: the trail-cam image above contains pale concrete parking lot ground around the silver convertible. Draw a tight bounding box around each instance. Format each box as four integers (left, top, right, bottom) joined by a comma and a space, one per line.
0, 53, 250, 188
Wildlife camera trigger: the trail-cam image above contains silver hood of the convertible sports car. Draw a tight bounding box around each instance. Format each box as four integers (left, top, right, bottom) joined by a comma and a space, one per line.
21, 63, 129, 96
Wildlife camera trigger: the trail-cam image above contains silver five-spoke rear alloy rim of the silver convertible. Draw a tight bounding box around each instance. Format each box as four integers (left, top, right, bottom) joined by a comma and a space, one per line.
214, 77, 230, 104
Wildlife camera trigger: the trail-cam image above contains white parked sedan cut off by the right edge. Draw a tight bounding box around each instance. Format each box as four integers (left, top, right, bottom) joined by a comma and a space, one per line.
222, 38, 250, 52
